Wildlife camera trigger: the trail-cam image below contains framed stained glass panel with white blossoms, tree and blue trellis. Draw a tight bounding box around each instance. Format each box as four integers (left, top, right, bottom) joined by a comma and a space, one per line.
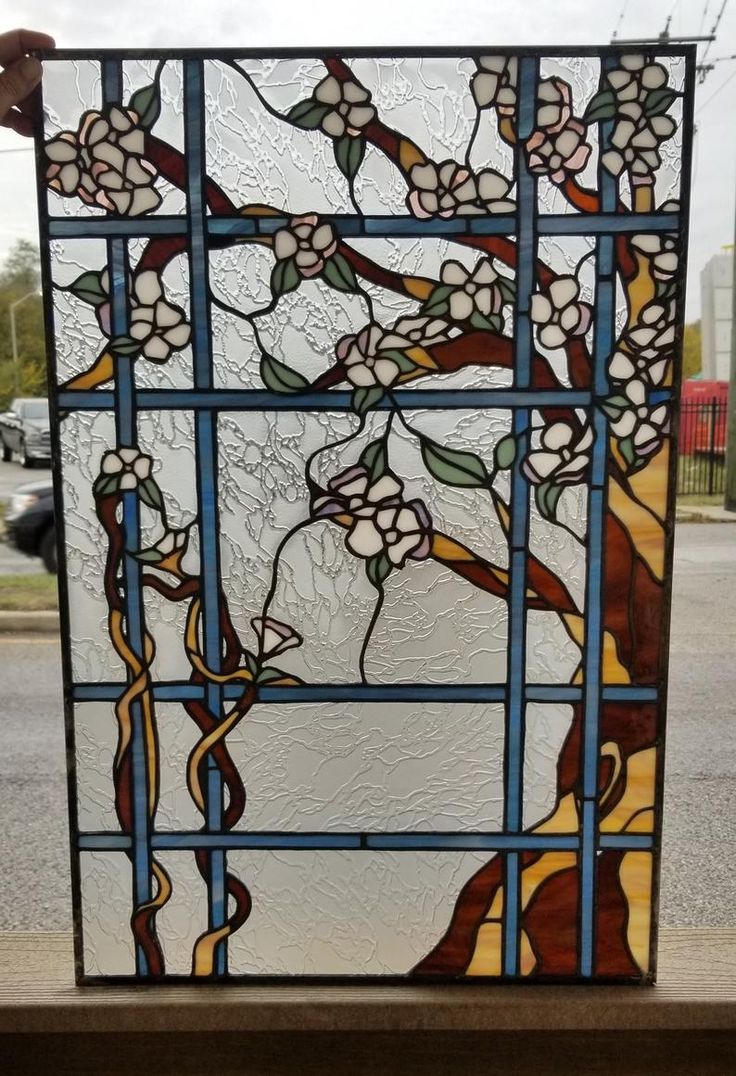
31, 47, 694, 981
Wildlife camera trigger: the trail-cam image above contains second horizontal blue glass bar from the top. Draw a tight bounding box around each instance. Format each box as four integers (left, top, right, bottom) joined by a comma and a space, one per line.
58, 388, 671, 411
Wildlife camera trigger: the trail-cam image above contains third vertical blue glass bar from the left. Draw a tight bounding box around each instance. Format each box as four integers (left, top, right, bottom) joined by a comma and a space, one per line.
504, 57, 538, 975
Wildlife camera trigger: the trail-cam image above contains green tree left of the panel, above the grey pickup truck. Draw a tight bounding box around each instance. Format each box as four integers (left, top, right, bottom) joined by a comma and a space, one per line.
0, 239, 46, 410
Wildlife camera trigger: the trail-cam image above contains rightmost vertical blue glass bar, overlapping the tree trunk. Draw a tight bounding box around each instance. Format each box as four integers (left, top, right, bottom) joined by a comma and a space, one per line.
580, 58, 618, 977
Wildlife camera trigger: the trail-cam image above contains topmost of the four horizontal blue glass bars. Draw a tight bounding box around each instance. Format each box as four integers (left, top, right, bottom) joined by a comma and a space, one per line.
48, 207, 680, 239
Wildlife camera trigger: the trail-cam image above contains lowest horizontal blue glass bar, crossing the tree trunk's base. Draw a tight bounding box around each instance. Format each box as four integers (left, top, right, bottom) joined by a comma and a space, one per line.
79, 831, 652, 852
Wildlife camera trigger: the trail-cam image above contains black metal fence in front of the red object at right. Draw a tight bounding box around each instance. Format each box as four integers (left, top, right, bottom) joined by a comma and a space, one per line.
677, 399, 727, 496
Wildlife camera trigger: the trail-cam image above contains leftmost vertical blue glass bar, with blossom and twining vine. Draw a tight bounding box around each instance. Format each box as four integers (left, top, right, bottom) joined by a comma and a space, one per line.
102, 60, 152, 975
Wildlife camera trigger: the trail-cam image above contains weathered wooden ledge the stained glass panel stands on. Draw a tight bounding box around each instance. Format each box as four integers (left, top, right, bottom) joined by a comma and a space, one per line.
0, 929, 736, 1035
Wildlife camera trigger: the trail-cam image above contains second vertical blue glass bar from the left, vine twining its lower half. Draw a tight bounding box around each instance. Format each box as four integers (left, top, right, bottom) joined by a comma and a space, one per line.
184, 59, 227, 975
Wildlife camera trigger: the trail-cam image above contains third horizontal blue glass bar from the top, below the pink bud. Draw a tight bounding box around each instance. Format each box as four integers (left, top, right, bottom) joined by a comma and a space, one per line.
73, 681, 657, 703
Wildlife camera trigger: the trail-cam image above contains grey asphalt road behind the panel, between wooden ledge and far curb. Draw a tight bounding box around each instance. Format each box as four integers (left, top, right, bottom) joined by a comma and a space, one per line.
0, 524, 736, 930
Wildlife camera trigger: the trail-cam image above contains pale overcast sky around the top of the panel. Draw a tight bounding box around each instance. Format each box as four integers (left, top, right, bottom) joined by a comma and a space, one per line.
0, 0, 736, 318
